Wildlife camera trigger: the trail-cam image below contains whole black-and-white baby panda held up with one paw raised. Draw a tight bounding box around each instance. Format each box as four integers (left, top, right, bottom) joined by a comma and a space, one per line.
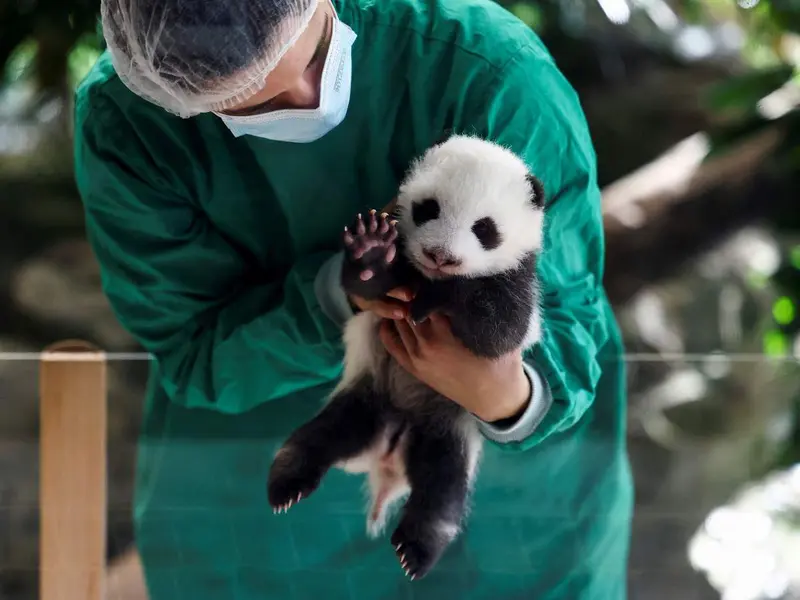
268, 135, 544, 580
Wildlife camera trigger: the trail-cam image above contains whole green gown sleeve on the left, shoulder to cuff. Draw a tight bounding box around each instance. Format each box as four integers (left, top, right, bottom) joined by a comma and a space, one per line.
75, 91, 342, 413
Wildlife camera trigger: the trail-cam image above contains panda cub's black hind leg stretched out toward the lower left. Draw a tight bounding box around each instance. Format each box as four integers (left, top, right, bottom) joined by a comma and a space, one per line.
267, 374, 387, 512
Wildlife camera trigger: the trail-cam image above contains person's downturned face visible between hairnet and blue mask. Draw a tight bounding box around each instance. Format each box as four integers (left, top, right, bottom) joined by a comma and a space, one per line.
220, 1, 335, 116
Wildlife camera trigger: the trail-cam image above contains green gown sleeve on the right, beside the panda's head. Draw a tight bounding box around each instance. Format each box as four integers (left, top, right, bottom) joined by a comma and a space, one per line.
465, 43, 608, 450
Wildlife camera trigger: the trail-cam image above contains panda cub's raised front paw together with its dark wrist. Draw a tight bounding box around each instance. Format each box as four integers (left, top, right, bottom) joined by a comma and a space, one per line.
342, 210, 397, 299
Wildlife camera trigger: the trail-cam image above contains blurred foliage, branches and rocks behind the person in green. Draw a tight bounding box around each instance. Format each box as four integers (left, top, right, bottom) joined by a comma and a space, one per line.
0, 0, 800, 600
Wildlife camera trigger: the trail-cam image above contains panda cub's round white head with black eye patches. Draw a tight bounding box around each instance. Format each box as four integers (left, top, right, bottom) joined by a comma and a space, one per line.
397, 135, 544, 279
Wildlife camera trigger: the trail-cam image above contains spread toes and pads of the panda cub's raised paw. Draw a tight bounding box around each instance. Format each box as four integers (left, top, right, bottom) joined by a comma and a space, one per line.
343, 210, 397, 281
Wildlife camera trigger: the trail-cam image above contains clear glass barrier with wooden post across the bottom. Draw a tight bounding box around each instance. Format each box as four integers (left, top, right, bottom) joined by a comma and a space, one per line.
0, 350, 800, 600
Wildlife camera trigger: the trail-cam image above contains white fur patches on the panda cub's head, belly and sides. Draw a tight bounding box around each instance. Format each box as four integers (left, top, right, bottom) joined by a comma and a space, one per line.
333, 136, 544, 536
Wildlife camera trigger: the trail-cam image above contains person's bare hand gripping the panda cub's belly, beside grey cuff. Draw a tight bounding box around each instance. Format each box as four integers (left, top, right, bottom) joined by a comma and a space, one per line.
380, 313, 531, 422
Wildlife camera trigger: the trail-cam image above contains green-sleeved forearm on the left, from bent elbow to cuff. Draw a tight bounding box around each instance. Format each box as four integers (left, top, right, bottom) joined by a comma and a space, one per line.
134, 248, 350, 413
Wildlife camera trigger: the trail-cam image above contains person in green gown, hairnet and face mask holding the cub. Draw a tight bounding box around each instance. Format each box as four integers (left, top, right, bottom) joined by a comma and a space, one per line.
75, 0, 633, 600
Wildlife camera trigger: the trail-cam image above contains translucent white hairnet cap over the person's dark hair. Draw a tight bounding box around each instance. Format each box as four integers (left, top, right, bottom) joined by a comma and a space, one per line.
101, 0, 318, 117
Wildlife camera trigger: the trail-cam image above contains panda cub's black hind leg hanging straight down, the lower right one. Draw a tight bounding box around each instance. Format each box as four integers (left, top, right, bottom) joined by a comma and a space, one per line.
391, 420, 474, 579
